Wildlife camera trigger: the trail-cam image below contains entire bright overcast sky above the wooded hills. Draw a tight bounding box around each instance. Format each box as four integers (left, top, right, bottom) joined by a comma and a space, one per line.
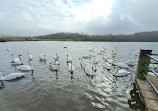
0, 0, 158, 36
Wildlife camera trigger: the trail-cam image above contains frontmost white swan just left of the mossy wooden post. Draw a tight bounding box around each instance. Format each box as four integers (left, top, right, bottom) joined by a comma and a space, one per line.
113, 66, 130, 77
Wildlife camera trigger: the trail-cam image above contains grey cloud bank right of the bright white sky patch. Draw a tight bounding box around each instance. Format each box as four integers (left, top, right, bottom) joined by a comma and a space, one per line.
82, 0, 158, 34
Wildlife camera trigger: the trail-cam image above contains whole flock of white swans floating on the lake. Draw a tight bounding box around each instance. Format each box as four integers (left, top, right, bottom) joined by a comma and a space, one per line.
0, 47, 138, 81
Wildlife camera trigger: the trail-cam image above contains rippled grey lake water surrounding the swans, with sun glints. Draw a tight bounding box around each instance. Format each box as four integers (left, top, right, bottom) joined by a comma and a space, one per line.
0, 42, 158, 111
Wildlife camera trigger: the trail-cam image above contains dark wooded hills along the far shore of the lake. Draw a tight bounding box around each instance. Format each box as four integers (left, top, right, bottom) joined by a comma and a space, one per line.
0, 31, 158, 42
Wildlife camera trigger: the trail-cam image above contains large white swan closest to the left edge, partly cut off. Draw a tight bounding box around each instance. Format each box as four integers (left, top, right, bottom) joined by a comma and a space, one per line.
0, 72, 25, 81
